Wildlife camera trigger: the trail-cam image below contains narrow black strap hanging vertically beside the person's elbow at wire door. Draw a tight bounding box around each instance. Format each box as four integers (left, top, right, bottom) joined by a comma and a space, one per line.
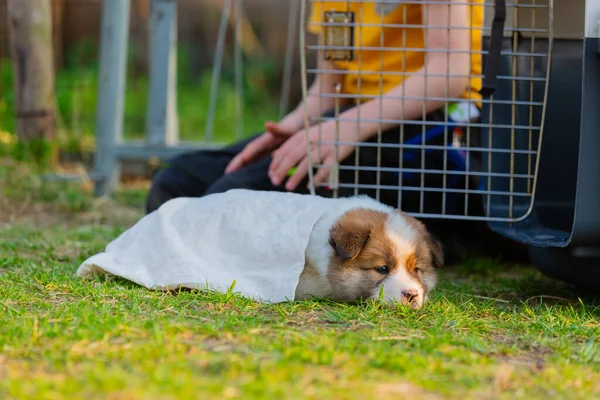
479, 0, 506, 97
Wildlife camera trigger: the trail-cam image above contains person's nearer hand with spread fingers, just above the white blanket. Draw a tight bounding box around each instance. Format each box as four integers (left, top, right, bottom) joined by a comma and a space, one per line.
269, 122, 356, 191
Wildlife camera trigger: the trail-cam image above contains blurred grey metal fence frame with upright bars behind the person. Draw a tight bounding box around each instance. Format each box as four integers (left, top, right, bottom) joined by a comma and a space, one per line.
93, 0, 300, 195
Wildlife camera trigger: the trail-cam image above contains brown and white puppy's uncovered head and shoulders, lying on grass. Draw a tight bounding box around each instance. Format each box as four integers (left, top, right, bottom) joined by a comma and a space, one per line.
295, 196, 444, 308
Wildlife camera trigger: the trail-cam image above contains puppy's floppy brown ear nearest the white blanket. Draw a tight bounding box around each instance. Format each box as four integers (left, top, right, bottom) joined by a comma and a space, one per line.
329, 209, 376, 261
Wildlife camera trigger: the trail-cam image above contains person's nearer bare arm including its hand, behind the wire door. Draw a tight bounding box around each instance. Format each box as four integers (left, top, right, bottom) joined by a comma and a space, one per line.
269, 0, 471, 190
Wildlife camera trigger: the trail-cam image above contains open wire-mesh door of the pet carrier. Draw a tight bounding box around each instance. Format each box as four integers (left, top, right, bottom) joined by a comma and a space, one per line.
300, 0, 552, 221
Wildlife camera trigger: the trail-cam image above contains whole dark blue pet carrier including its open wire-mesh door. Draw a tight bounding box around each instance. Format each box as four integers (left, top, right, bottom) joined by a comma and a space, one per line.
300, 0, 600, 287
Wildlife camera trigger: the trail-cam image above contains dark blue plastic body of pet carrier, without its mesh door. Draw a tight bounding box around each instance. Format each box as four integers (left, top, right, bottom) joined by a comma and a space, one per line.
490, 0, 600, 290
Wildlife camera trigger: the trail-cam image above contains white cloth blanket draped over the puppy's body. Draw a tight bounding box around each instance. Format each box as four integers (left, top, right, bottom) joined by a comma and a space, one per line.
77, 190, 339, 302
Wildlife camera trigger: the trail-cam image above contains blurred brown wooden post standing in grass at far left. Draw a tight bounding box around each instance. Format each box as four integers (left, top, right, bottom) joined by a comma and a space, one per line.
7, 0, 56, 150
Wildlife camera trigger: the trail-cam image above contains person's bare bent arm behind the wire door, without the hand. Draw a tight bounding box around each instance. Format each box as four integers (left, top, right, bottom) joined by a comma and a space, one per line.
340, 0, 471, 141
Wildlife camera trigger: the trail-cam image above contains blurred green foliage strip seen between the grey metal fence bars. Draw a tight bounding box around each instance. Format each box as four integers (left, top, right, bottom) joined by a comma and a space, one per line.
0, 43, 279, 153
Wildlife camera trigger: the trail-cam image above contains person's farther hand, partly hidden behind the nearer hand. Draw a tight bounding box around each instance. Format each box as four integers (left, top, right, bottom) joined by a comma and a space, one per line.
225, 120, 296, 174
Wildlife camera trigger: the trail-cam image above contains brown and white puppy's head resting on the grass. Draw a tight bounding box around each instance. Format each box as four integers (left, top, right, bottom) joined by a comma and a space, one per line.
328, 208, 444, 308
